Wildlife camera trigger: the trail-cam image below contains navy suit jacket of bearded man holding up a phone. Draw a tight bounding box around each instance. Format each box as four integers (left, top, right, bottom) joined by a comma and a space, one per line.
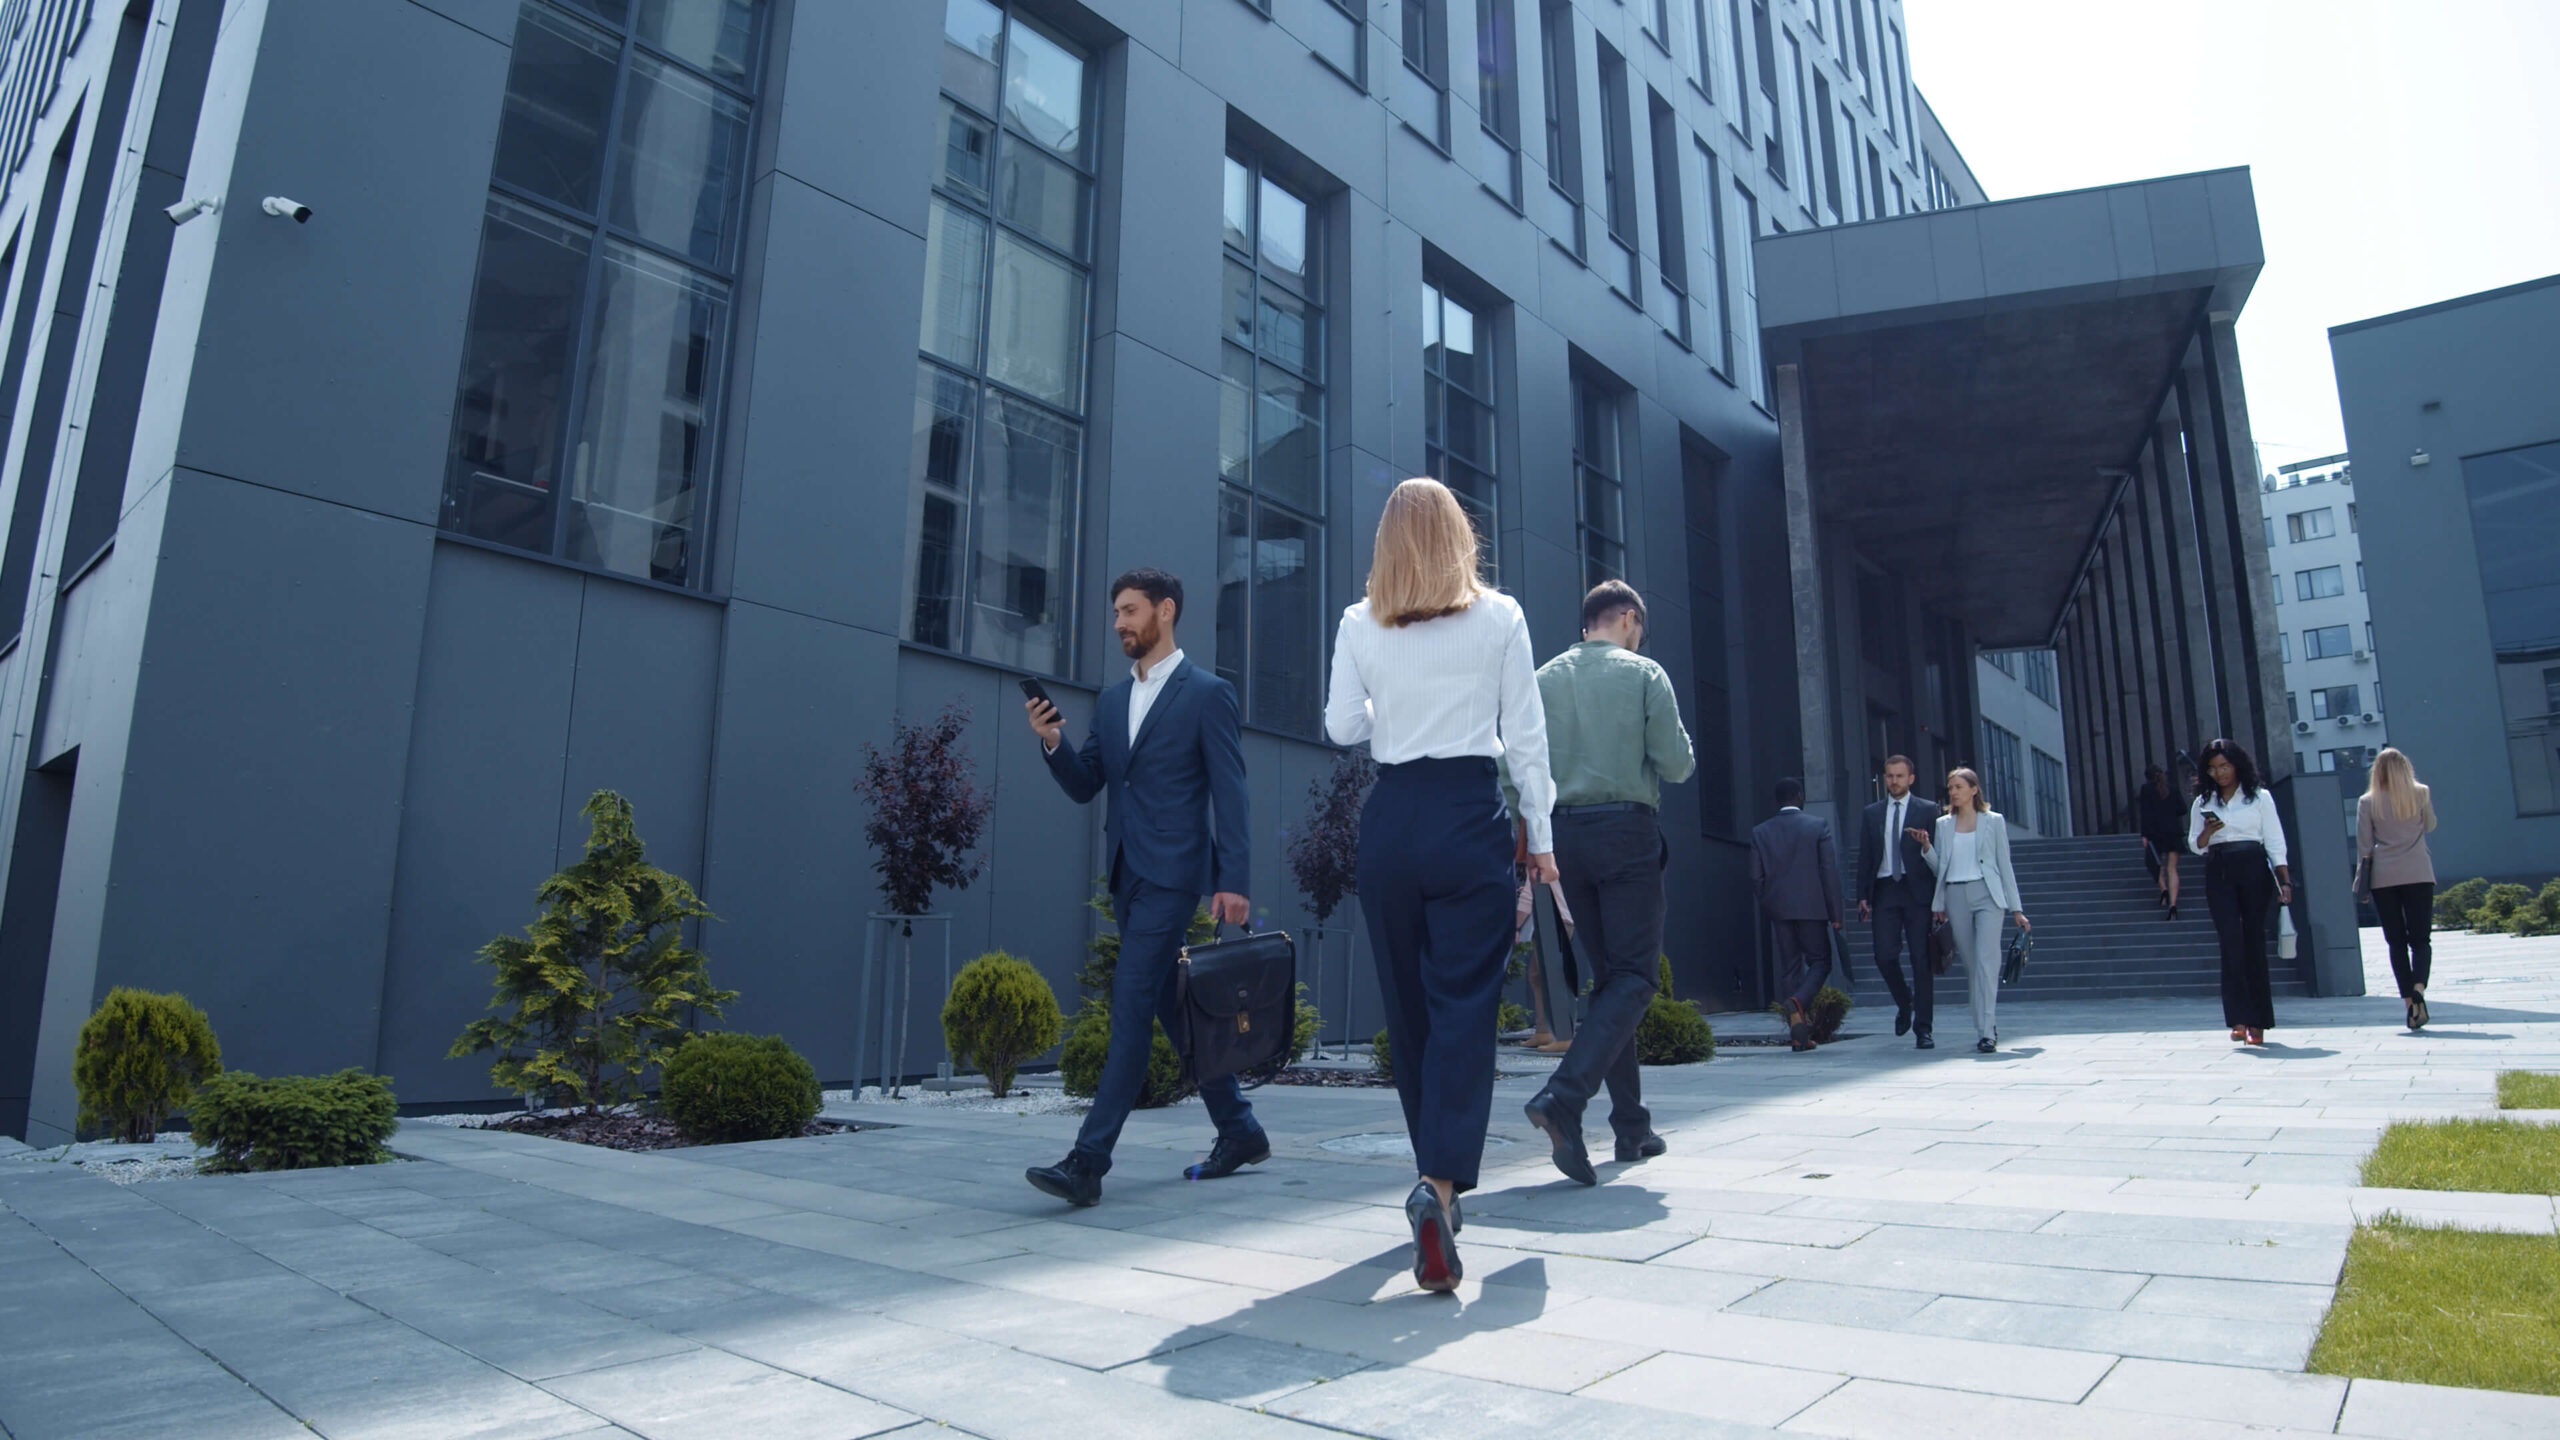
1050, 656, 1252, 894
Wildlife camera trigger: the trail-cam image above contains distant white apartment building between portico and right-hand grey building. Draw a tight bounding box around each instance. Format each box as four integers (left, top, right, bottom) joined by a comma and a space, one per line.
2260, 456, 2388, 794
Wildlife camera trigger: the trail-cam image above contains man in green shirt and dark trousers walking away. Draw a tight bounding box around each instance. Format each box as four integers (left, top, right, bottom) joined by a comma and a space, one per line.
1528, 579, 1697, 1184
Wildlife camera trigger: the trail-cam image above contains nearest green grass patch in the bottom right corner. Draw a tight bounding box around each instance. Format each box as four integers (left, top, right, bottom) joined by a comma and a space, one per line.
2312, 1215, 2560, 1394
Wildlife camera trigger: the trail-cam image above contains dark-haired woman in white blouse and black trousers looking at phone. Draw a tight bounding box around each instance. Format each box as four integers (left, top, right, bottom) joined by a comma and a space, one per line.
2186, 740, 2294, 1045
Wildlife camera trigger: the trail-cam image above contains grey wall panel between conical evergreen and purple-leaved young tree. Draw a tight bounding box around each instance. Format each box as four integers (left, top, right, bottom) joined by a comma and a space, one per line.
701, 602, 899, 1079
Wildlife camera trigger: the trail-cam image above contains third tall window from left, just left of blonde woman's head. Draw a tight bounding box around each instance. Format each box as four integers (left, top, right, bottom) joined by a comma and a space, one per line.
1219, 156, 1324, 735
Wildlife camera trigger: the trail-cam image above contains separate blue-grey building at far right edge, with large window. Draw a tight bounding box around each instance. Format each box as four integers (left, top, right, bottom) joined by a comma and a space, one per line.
2330, 274, 2560, 884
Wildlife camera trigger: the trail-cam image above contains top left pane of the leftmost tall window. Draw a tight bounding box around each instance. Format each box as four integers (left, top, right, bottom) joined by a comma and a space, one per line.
492, 5, 622, 213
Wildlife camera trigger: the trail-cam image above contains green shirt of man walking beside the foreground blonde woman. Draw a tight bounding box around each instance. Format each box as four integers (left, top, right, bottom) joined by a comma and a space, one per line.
1505, 641, 1697, 807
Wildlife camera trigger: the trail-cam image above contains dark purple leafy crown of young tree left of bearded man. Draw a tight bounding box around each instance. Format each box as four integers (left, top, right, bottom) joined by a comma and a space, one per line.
852, 705, 996, 915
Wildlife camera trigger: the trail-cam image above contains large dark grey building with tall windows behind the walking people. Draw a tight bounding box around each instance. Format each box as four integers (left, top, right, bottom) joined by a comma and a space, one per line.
0, 0, 2324, 1140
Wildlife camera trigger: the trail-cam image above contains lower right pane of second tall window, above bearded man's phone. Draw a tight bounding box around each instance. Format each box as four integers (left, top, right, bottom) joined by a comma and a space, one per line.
968, 395, 1083, 674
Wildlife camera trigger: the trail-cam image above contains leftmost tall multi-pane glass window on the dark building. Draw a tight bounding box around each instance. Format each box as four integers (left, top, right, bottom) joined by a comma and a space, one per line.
440, 0, 765, 584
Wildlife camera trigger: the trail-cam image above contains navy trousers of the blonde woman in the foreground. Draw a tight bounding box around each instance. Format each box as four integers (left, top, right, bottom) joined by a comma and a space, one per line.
1359, 756, 1518, 1189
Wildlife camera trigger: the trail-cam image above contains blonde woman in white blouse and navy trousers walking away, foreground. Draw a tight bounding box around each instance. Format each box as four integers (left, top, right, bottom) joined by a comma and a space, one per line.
1324, 479, 1556, 1291
